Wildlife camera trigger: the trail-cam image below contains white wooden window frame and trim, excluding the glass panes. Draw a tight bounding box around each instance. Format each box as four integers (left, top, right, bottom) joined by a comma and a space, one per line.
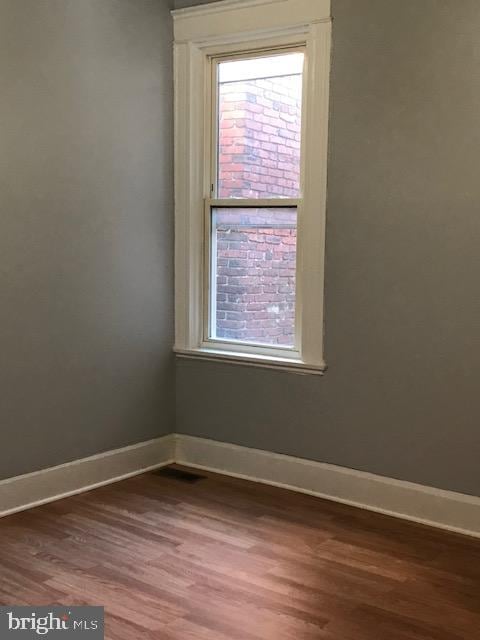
172, 0, 331, 373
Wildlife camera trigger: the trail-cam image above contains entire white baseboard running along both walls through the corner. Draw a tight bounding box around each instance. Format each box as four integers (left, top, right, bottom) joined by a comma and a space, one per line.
0, 434, 480, 538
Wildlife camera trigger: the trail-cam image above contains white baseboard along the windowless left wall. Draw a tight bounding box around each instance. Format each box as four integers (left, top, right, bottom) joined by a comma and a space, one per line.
0, 435, 175, 517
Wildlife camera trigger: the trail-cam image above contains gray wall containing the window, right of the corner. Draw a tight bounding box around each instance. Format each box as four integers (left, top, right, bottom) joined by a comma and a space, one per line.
177, 0, 480, 494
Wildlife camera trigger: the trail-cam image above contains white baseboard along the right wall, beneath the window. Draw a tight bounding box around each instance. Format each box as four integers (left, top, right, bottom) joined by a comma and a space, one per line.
175, 434, 480, 537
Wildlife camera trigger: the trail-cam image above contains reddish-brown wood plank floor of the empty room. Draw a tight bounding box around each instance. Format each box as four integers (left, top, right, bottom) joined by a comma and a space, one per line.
0, 464, 480, 640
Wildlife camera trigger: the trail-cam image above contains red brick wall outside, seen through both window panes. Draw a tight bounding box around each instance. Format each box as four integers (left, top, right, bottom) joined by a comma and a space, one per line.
216, 76, 301, 345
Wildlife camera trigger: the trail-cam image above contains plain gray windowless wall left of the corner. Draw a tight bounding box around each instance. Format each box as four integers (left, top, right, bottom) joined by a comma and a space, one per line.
0, 0, 174, 477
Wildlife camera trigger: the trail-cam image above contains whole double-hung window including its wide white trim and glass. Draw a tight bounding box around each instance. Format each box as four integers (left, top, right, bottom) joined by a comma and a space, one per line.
173, 0, 330, 373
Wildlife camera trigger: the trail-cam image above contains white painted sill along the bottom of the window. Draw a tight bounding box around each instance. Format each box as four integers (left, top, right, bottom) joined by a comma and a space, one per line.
174, 348, 327, 376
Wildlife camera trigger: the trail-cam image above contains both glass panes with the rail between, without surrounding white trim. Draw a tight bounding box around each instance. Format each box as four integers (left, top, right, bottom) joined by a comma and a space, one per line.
211, 50, 304, 349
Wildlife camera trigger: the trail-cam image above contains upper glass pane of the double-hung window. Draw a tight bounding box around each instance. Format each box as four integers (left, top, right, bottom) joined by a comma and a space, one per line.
217, 53, 304, 198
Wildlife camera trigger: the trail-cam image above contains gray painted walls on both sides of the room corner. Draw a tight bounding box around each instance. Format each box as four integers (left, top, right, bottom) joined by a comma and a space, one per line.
0, 0, 480, 494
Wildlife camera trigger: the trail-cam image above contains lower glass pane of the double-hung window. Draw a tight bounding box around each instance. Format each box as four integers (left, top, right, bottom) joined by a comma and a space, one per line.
210, 208, 297, 347
